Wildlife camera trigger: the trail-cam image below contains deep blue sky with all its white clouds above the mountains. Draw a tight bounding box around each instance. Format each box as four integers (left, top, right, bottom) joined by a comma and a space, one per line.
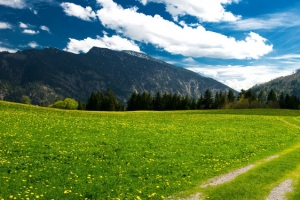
0, 0, 300, 91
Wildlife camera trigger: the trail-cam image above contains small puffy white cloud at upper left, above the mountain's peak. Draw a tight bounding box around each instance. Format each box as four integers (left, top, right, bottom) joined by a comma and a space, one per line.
60, 2, 96, 21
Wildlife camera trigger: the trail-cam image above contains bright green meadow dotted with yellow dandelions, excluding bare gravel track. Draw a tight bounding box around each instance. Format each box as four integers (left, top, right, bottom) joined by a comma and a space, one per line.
0, 101, 300, 200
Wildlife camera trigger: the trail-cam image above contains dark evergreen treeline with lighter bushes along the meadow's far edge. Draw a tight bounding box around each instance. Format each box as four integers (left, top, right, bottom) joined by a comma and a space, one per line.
18, 88, 300, 111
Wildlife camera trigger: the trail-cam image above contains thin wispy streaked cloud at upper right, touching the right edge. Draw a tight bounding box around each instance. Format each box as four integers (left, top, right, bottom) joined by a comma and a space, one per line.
230, 10, 300, 30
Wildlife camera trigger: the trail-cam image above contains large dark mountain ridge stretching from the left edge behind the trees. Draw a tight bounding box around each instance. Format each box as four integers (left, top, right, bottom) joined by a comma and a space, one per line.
0, 47, 234, 104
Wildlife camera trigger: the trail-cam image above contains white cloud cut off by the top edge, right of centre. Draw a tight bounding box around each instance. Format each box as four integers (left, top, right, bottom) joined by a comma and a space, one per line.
140, 0, 241, 22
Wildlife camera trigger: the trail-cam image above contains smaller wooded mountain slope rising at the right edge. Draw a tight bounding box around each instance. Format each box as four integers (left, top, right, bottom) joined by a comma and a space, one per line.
251, 70, 300, 97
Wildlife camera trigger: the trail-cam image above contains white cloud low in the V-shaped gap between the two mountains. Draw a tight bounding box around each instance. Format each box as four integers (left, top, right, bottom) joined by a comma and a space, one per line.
187, 65, 297, 91
